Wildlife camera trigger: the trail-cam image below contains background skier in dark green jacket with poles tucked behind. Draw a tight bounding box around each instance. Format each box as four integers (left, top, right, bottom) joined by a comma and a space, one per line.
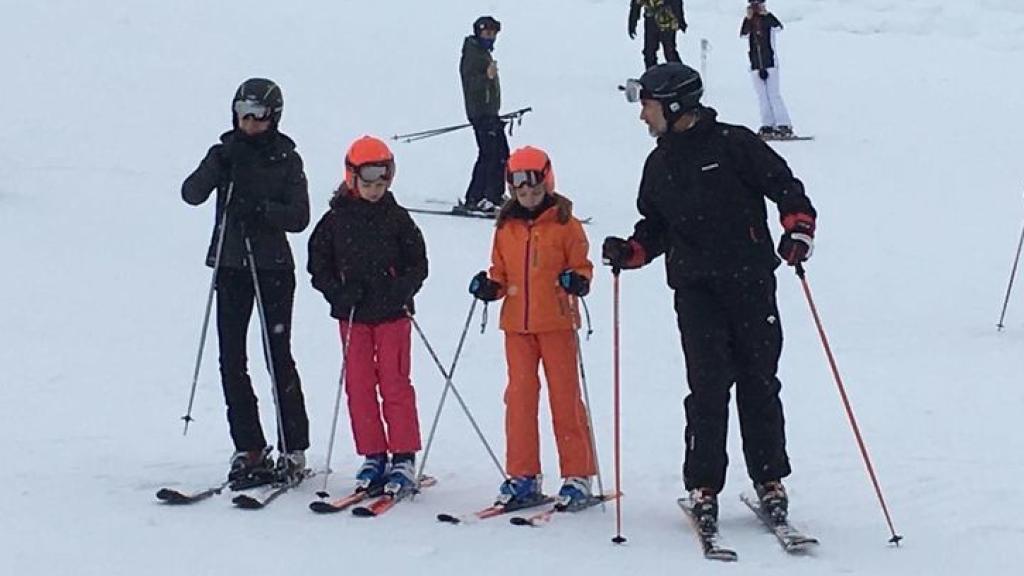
459, 16, 509, 213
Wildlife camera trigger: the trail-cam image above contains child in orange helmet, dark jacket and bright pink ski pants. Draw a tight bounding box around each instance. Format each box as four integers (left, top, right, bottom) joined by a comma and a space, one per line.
308, 136, 427, 495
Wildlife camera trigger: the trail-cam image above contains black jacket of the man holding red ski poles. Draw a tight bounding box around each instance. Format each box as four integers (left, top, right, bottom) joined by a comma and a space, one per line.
632, 108, 816, 288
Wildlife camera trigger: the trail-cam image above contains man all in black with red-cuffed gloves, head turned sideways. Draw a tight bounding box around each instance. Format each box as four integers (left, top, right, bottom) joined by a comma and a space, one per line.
602, 64, 816, 528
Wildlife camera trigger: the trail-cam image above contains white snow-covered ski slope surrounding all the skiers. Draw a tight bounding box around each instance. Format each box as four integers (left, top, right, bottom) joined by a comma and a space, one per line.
0, 0, 1024, 576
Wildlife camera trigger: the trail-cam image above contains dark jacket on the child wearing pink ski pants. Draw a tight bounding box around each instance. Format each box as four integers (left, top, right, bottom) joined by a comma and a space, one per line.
308, 184, 427, 324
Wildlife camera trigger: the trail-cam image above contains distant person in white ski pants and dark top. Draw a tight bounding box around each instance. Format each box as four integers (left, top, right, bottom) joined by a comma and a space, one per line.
739, 0, 793, 138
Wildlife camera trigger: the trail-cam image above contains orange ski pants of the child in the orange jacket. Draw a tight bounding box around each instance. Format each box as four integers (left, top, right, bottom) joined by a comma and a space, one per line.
505, 330, 596, 478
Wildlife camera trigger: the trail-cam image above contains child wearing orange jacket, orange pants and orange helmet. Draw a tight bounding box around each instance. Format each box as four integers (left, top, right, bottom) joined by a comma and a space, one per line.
469, 147, 596, 507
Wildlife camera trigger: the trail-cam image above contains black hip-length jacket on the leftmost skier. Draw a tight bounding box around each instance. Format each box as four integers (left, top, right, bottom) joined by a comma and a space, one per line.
181, 130, 309, 270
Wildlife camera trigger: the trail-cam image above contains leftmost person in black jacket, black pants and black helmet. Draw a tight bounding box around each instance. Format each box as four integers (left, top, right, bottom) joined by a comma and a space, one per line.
181, 78, 309, 486
